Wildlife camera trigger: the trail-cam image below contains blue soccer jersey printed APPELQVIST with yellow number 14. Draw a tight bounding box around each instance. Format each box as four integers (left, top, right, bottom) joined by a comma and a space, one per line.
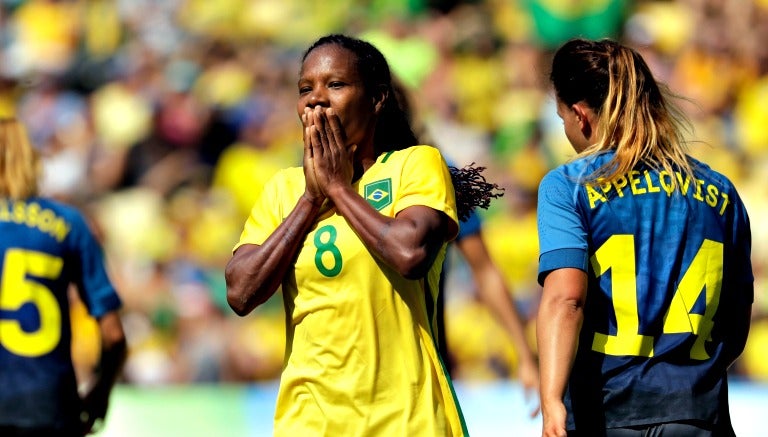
538, 153, 753, 430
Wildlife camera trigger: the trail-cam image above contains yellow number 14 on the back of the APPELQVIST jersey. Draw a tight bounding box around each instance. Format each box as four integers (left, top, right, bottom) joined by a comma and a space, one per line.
590, 235, 723, 360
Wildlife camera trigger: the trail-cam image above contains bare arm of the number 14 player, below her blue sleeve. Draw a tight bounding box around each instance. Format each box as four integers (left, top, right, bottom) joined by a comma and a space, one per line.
536, 268, 587, 437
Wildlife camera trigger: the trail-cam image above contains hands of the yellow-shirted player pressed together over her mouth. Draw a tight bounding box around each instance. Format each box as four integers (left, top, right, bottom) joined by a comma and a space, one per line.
307, 106, 356, 197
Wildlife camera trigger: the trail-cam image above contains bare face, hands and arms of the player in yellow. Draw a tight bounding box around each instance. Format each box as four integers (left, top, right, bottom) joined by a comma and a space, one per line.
225, 45, 456, 316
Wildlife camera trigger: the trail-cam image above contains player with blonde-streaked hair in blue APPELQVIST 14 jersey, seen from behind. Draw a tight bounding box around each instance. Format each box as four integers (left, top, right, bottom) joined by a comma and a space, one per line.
537, 39, 753, 436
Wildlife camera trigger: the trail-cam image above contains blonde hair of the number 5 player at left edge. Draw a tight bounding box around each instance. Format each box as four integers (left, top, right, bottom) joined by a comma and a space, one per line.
0, 118, 41, 199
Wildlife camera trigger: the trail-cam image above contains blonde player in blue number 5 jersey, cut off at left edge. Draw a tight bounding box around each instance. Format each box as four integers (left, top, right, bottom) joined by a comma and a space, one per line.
0, 118, 126, 437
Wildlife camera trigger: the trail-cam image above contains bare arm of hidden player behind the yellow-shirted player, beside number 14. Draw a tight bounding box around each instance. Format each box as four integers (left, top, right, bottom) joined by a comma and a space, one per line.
456, 233, 539, 415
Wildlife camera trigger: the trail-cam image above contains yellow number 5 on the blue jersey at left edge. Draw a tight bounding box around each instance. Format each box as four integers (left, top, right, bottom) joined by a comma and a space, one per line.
0, 249, 64, 357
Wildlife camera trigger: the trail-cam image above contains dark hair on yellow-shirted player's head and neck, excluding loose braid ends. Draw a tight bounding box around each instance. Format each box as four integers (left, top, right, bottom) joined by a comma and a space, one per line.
301, 34, 419, 154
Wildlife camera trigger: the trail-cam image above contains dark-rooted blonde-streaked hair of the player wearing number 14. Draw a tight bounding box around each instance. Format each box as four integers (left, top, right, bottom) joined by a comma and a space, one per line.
550, 39, 693, 184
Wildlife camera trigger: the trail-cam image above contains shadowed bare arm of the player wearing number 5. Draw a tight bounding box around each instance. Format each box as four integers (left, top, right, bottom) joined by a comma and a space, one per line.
83, 311, 127, 432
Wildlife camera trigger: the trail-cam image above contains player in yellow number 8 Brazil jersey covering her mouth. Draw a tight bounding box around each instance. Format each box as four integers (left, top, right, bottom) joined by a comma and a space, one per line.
226, 35, 498, 436
